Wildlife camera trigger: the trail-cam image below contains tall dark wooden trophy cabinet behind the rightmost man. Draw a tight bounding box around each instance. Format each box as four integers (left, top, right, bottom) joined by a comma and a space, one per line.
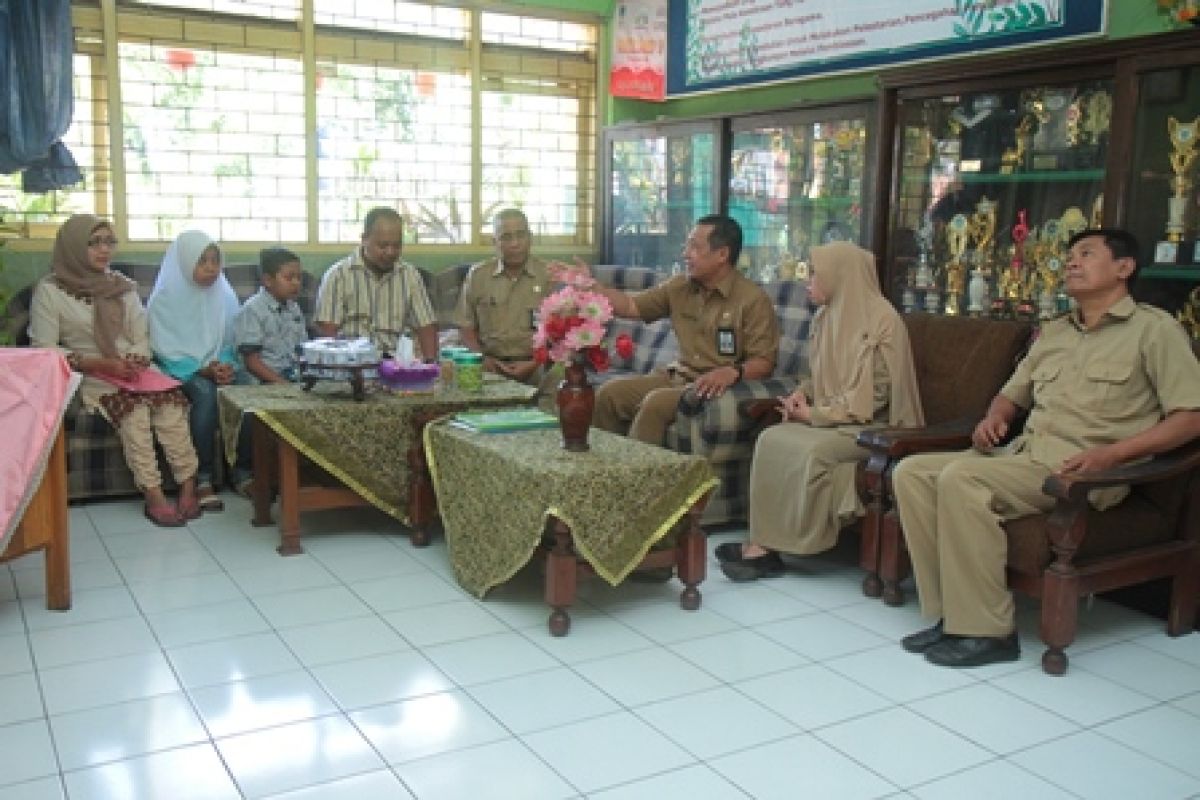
872, 30, 1200, 336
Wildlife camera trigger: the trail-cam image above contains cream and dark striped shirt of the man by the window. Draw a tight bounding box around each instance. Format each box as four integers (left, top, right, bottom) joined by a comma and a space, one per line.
316, 248, 437, 355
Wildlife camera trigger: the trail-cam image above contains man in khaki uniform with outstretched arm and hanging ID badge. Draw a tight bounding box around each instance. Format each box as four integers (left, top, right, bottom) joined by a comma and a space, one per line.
576, 215, 779, 445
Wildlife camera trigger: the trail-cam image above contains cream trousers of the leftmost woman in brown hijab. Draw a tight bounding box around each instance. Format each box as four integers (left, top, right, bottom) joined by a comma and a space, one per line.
116, 403, 199, 491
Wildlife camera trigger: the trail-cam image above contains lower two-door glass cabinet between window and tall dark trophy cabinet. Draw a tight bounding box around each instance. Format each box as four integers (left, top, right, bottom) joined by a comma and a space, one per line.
600, 100, 877, 275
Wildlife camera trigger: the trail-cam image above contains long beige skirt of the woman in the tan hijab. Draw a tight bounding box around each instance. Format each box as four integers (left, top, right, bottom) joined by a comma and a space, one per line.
750, 422, 868, 555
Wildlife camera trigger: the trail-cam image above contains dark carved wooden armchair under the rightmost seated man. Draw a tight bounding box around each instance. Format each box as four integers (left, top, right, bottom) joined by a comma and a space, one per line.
858, 343, 1200, 675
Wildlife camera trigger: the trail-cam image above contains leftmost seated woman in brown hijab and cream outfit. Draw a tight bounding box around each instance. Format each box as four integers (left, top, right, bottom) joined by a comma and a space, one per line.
29, 213, 200, 528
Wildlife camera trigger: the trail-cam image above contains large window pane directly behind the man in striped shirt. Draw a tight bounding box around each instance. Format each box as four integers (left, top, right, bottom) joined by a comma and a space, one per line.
317, 61, 470, 243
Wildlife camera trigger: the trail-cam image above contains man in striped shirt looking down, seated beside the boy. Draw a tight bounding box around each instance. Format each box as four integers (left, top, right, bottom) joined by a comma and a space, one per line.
316, 206, 438, 360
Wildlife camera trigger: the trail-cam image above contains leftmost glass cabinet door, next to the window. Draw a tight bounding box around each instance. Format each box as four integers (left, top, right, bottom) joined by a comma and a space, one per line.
602, 121, 720, 271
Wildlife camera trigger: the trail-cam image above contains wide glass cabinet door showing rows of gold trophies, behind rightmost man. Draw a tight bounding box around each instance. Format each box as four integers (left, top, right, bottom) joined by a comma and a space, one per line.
888, 80, 1112, 319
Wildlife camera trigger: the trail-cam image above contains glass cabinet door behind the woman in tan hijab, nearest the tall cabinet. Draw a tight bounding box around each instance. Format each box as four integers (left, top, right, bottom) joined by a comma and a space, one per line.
728, 103, 874, 282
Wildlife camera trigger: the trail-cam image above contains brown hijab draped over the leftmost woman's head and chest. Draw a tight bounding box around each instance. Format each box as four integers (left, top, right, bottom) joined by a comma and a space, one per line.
50, 213, 137, 359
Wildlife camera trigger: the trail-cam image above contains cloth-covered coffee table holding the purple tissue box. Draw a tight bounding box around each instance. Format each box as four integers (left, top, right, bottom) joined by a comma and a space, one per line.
218, 375, 536, 555
